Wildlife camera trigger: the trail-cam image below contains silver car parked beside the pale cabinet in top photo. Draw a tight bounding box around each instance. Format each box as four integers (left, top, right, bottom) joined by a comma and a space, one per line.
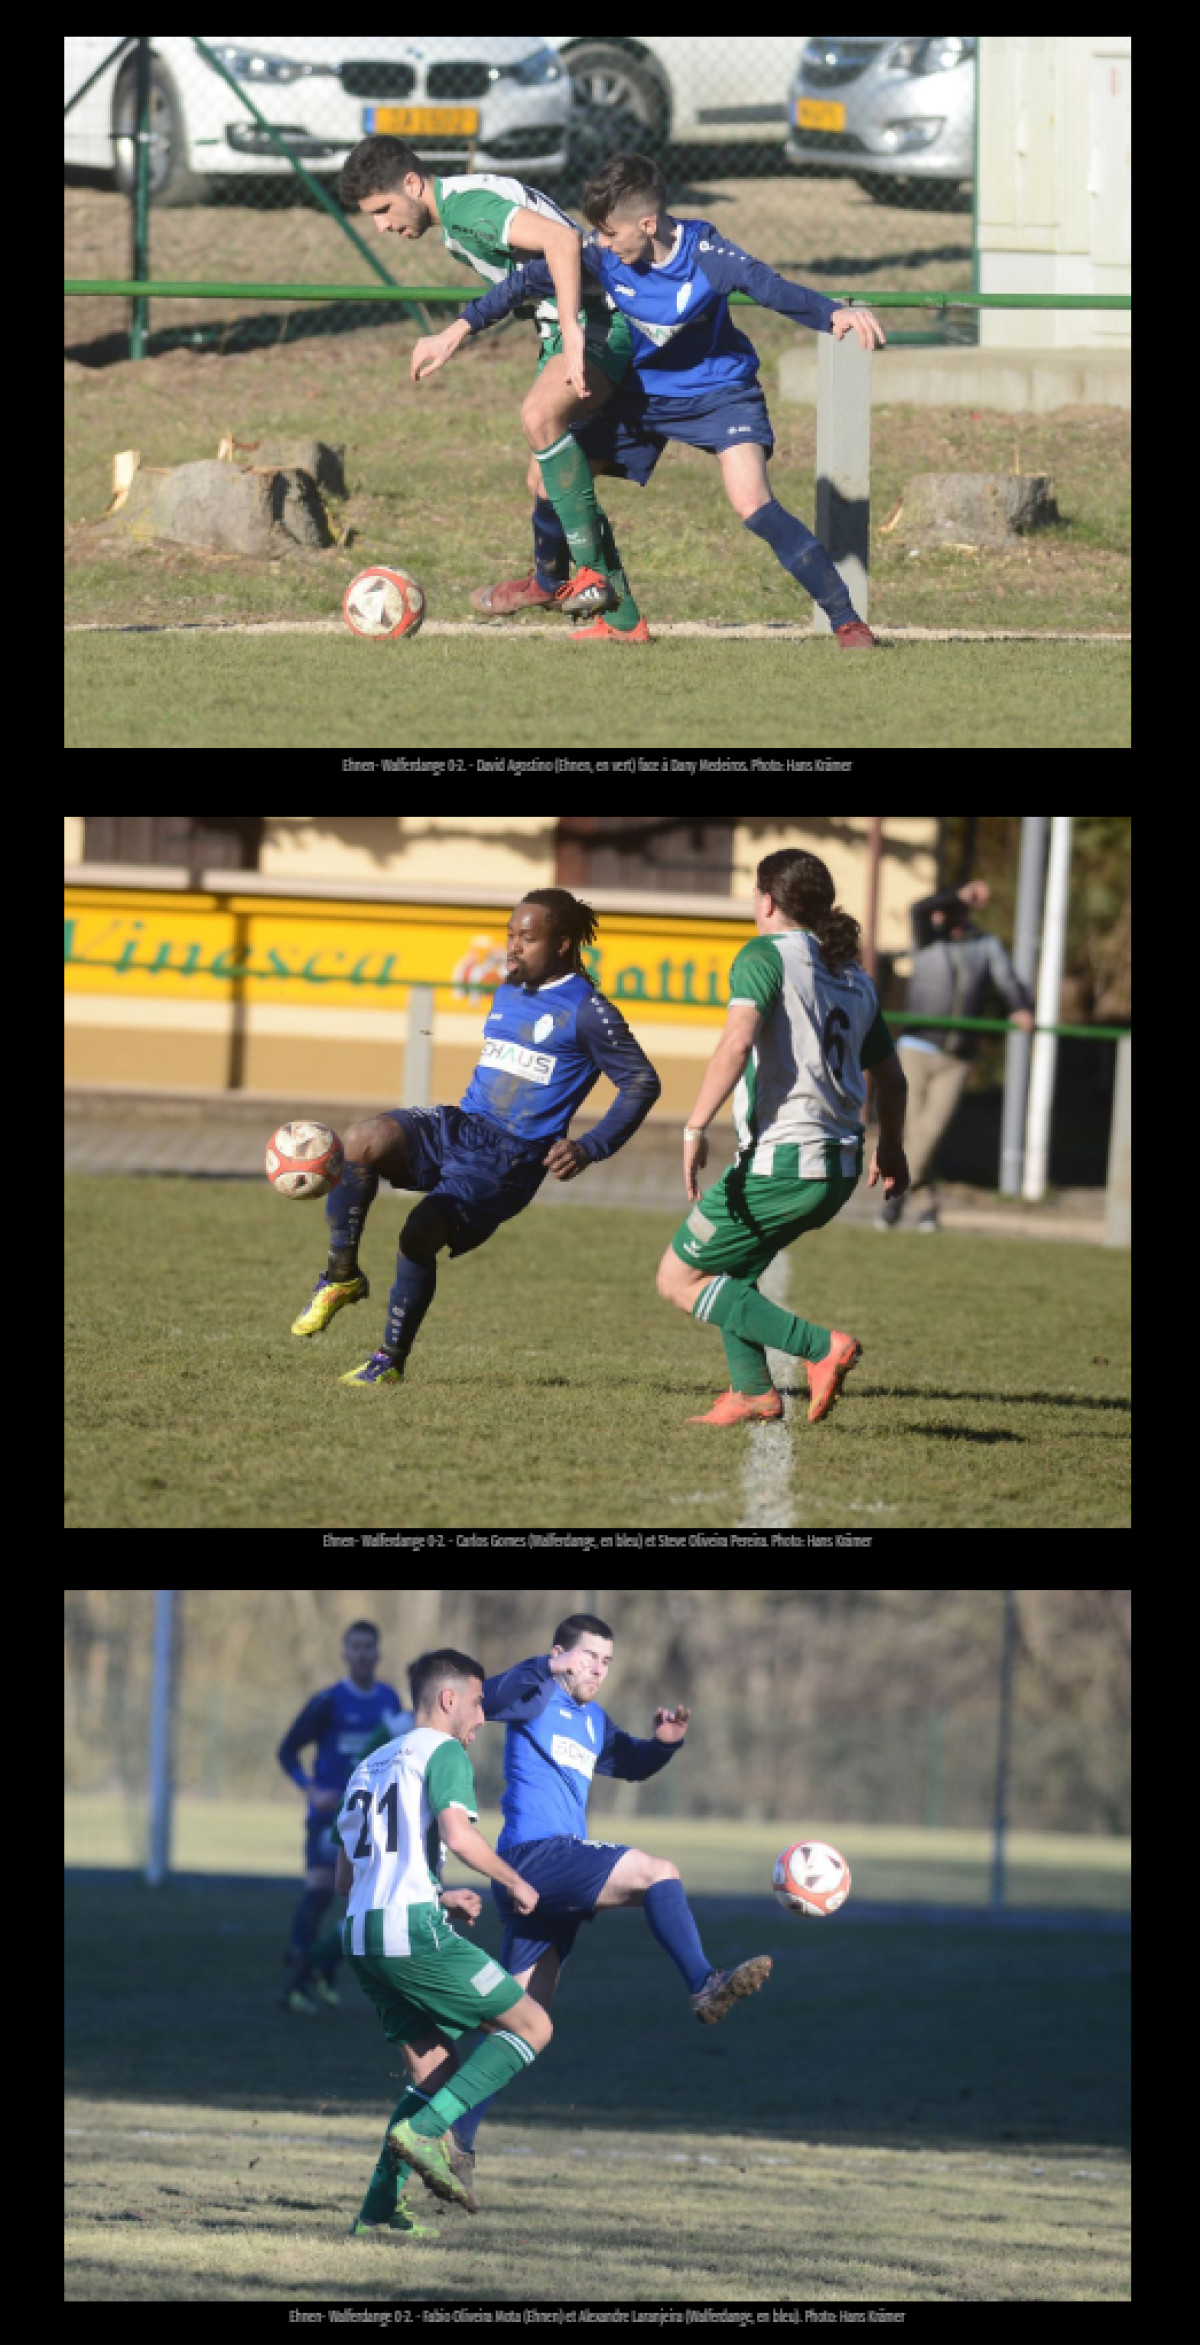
783, 33, 975, 204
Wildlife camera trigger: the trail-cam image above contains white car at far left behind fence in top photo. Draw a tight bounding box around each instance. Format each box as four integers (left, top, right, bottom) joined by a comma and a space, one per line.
63, 33, 572, 204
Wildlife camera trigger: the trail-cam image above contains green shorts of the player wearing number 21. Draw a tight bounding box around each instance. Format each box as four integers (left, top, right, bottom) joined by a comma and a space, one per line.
342, 1904, 525, 2045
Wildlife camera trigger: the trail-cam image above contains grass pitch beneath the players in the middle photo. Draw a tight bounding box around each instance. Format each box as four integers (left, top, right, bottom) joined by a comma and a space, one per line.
66, 1175, 1130, 1531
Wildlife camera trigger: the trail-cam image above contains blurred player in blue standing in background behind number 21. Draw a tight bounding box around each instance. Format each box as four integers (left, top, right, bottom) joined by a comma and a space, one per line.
279, 1620, 410, 2014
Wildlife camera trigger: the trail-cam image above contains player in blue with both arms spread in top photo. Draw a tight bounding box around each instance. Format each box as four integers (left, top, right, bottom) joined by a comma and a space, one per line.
413, 155, 884, 650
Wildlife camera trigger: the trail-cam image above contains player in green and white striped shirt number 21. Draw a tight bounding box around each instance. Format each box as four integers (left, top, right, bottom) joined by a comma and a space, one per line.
338, 1649, 553, 2237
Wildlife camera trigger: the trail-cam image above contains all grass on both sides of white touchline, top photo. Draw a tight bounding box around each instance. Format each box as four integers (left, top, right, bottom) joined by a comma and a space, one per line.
66, 316, 1130, 755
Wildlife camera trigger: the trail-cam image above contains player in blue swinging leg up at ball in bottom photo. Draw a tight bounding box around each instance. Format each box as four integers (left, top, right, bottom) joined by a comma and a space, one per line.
450, 1613, 771, 2186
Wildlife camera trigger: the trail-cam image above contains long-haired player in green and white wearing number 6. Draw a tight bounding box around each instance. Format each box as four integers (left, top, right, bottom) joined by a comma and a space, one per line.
659, 847, 909, 1426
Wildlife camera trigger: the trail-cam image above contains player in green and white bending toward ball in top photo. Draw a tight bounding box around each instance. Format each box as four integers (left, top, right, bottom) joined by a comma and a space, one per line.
338, 134, 647, 643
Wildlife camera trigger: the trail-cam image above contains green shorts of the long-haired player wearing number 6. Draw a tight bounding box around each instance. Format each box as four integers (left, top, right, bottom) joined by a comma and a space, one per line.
670, 1140, 863, 1283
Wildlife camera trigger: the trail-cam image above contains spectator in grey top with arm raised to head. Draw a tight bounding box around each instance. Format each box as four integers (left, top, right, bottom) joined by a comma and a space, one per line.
874, 879, 1034, 1231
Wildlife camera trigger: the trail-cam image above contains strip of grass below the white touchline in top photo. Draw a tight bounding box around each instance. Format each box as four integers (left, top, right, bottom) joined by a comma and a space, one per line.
66, 626, 1130, 757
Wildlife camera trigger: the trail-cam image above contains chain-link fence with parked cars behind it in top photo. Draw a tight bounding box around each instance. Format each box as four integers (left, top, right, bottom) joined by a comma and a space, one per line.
63, 35, 975, 363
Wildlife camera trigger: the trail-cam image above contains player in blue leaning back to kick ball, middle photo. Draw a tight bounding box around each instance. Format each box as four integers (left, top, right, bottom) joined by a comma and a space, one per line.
293, 886, 661, 1388
